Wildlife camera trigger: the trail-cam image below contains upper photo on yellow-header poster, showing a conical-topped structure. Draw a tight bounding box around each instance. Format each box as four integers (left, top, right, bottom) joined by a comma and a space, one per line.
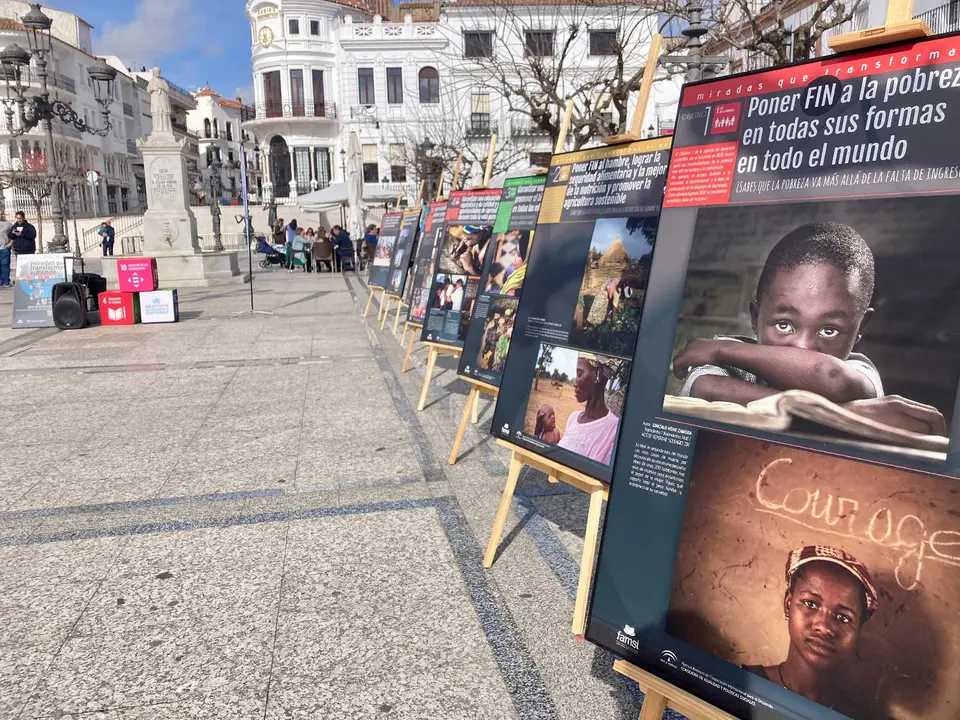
570, 218, 657, 356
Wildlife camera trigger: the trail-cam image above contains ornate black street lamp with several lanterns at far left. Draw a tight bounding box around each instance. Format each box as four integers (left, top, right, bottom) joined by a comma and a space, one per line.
0, 3, 117, 252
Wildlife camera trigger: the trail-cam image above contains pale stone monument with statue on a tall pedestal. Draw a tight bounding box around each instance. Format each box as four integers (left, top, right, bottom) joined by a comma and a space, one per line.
124, 67, 240, 287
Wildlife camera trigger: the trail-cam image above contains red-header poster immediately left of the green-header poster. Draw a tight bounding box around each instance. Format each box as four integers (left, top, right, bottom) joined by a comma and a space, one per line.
420, 189, 501, 347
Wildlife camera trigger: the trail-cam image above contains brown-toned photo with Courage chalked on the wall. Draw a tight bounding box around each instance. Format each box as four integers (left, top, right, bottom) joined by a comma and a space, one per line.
666, 432, 960, 720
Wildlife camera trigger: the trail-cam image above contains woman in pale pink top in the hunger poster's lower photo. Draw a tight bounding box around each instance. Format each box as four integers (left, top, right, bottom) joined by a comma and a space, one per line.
557, 353, 620, 465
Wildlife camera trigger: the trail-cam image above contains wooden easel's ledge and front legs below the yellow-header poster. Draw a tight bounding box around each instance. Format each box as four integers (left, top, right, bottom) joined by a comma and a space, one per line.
483, 440, 609, 639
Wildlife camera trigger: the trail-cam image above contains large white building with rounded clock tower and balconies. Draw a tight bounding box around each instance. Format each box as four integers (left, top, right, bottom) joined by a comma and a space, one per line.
244, 0, 678, 203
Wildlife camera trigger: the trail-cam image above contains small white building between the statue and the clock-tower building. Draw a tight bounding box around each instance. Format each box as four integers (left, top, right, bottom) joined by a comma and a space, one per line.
187, 87, 262, 205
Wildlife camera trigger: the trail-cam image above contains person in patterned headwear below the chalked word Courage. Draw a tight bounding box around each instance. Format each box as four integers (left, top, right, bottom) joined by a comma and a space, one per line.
744, 545, 878, 718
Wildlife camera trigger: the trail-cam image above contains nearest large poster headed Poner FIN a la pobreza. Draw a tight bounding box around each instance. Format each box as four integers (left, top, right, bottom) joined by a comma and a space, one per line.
587, 36, 960, 720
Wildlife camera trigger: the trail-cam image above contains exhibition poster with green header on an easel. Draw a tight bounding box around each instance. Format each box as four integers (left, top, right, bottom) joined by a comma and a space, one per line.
458, 175, 547, 387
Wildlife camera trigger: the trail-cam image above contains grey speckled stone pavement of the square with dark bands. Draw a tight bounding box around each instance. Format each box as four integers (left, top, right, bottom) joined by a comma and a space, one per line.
0, 264, 676, 720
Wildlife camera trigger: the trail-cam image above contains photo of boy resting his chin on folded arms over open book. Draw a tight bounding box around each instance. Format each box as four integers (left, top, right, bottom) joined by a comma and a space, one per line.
666, 198, 960, 457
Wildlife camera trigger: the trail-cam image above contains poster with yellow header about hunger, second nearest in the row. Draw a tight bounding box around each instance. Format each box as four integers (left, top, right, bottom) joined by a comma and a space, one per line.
491, 139, 670, 482
